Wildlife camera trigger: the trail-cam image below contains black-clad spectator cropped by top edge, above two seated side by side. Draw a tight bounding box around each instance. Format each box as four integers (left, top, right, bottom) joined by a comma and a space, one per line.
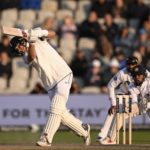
91, 0, 111, 18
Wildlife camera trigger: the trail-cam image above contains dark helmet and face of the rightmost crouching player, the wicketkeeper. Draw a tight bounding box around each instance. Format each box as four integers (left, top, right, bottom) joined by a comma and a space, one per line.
132, 65, 146, 86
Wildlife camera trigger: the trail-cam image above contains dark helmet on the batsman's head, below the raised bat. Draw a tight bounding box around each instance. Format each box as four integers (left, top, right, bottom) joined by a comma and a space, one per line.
9, 36, 27, 56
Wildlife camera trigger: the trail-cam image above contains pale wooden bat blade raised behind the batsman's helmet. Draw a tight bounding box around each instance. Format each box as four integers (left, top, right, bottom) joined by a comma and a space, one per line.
2, 26, 23, 37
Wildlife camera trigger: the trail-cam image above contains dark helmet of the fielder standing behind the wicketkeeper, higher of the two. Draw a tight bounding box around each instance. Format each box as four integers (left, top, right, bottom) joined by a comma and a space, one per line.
126, 56, 138, 73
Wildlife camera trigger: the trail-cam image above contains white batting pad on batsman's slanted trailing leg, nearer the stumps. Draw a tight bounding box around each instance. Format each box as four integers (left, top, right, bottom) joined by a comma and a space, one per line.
62, 110, 88, 137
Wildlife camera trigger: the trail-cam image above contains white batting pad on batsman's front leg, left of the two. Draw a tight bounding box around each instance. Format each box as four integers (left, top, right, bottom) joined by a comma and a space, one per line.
41, 113, 61, 143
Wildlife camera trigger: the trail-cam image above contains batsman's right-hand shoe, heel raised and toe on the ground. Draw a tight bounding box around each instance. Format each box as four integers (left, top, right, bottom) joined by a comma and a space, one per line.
82, 124, 91, 146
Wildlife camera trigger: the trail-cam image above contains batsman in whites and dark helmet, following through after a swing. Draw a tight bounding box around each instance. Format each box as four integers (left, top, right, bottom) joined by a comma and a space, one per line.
10, 28, 91, 147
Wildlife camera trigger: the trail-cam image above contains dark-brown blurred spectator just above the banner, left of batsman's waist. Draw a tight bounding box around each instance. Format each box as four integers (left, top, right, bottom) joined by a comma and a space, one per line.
30, 82, 47, 94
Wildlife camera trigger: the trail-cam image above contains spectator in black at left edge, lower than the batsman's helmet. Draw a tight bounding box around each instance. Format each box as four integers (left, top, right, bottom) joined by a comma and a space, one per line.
0, 51, 13, 88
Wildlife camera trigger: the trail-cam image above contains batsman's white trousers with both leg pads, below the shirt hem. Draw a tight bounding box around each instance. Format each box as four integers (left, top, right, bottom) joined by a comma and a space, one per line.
41, 74, 88, 143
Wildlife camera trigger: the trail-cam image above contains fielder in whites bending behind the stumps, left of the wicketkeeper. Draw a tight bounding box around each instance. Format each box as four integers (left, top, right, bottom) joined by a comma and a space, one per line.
96, 56, 150, 145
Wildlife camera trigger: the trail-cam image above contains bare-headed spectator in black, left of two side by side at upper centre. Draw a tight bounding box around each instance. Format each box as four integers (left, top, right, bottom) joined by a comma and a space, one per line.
79, 11, 101, 43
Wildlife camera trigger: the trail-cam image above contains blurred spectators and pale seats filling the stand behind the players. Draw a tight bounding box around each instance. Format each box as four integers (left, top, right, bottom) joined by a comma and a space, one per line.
0, 0, 150, 94
